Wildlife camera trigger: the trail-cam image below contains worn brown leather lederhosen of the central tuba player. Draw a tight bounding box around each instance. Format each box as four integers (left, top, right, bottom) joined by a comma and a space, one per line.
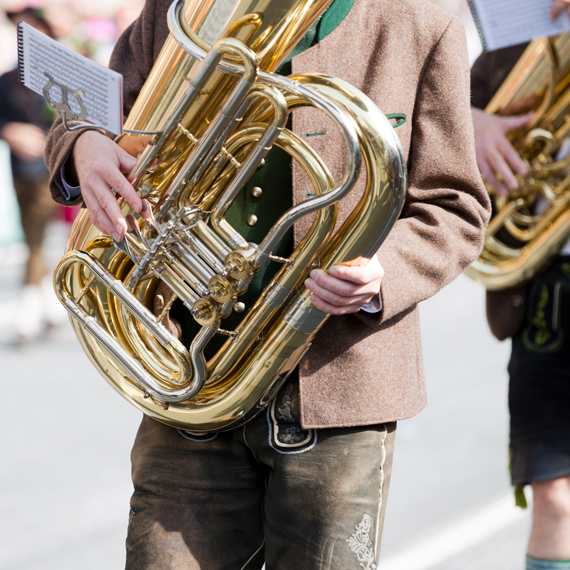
126, 394, 397, 570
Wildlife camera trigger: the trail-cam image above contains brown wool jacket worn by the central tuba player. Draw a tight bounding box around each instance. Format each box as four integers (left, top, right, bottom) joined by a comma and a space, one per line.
46, 0, 490, 428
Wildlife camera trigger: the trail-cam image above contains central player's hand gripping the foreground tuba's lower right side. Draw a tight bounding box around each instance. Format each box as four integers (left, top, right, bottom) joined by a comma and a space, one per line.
305, 256, 384, 315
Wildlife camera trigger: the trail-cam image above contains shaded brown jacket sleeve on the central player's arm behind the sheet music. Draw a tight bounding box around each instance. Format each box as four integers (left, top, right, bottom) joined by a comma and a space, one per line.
45, 0, 167, 206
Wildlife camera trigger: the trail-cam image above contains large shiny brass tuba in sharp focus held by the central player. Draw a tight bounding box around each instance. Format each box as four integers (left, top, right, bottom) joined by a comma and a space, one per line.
54, 0, 406, 433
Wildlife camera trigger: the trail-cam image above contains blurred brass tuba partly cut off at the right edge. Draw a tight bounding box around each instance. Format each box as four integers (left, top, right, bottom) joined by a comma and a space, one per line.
466, 33, 570, 290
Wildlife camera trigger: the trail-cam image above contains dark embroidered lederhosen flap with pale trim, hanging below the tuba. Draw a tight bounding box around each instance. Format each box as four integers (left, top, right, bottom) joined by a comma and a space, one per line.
267, 382, 317, 453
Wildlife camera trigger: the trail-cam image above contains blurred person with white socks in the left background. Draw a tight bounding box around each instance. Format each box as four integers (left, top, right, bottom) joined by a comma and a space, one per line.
0, 7, 65, 344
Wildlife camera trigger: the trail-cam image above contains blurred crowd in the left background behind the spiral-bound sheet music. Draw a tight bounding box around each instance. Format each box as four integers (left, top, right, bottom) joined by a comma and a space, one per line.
0, 0, 144, 346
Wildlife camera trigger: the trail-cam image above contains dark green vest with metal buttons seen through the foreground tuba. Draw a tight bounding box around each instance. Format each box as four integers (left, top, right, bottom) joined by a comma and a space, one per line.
170, 0, 355, 352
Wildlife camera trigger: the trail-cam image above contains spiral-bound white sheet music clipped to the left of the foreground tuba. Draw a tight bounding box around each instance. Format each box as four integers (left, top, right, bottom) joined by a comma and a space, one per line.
18, 22, 123, 134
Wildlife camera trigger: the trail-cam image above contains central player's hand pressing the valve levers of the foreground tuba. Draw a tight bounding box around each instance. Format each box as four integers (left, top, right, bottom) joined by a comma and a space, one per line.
73, 131, 148, 241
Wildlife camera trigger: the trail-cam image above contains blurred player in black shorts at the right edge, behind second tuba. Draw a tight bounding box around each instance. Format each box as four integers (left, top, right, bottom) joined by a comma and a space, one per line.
471, 0, 570, 570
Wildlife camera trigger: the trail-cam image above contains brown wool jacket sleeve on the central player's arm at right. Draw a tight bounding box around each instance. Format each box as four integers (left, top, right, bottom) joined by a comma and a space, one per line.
358, 18, 491, 325
